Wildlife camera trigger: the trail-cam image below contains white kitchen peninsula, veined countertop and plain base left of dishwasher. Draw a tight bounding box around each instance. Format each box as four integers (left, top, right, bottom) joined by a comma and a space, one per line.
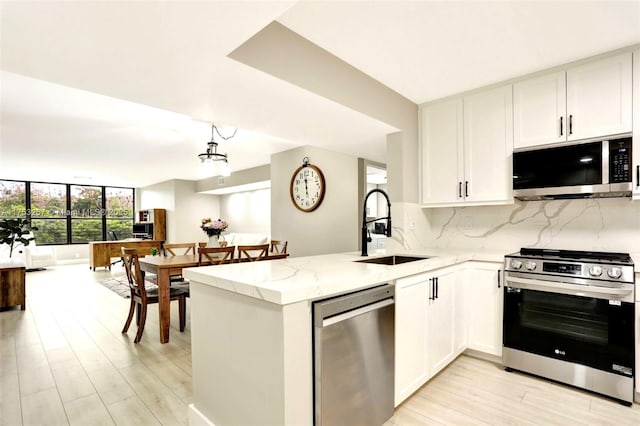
184, 250, 505, 426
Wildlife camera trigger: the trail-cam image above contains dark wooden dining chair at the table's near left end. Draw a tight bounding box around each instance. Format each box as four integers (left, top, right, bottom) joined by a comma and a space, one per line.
122, 247, 187, 343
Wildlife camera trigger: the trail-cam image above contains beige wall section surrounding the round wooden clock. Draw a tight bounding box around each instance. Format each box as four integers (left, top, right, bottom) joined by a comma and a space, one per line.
271, 146, 362, 256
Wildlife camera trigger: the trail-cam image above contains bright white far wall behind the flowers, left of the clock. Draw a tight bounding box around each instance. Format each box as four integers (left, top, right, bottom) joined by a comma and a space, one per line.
220, 189, 270, 239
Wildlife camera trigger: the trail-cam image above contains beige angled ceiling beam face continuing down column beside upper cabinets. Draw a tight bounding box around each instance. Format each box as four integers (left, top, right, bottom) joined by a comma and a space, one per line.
229, 21, 418, 202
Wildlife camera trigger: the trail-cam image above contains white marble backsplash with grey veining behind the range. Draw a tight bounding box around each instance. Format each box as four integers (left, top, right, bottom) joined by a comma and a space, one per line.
387, 198, 640, 253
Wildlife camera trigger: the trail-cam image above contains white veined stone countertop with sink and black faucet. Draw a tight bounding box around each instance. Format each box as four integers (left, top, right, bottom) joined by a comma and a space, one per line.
183, 249, 507, 305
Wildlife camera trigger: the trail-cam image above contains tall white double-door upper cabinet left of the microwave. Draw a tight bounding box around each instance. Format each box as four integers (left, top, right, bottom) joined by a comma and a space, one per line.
421, 85, 513, 206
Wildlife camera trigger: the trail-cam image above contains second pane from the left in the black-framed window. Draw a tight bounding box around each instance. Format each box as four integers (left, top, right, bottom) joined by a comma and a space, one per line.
30, 183, 67, 244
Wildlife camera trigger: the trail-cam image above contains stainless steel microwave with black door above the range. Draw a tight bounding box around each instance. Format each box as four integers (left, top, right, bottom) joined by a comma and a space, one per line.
513, 135, 632, 200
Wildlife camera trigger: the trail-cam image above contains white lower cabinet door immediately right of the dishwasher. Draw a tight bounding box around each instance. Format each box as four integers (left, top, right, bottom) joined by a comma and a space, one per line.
395, 274, 429, 406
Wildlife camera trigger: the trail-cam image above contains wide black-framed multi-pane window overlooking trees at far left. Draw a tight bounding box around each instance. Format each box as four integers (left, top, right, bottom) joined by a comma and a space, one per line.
0, 180, 134, 244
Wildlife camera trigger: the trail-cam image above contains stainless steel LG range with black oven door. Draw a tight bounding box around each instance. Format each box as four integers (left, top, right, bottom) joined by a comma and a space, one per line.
502, 248, 635, 405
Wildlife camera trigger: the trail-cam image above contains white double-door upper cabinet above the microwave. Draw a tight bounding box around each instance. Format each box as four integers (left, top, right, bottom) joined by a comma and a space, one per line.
513, 52, 632, 148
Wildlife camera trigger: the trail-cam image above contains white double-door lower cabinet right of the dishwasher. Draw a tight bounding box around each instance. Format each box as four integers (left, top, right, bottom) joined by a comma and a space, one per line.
395, 267, 466, 406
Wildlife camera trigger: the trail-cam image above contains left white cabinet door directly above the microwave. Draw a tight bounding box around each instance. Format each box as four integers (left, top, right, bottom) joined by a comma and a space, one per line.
513, 71, 567, 149
